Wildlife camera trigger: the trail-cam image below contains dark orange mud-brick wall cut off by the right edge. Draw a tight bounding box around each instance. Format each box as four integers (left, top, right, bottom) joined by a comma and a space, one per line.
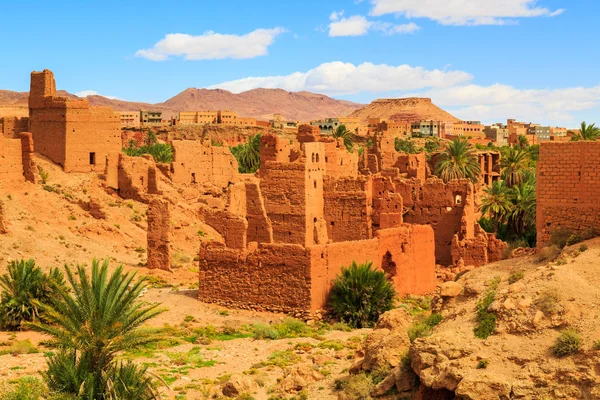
536, 141, 600, 247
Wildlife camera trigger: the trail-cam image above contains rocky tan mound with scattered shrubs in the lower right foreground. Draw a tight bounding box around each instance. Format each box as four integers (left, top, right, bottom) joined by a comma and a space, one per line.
344, 239, 600, 400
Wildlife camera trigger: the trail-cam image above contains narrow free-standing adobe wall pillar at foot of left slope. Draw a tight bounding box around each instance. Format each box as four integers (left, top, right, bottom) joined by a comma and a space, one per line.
147, 196, 171, 271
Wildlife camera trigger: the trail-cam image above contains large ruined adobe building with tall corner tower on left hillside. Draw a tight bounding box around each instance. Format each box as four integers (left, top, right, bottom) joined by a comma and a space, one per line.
29, 70, 121, 172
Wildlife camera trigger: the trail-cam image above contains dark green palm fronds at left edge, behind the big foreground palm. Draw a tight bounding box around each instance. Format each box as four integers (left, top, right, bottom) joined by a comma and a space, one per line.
0, 259, 64, 330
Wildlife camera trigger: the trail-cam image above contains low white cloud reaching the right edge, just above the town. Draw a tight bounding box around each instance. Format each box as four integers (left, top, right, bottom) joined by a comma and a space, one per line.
418, 84, 600, 123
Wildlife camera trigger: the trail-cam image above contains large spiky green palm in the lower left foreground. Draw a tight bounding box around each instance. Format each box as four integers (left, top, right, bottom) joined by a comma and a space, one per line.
28, 260, 164, 400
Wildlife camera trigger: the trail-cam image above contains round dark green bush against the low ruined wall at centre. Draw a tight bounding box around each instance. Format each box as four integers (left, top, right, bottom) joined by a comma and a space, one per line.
329, 261, 396, 328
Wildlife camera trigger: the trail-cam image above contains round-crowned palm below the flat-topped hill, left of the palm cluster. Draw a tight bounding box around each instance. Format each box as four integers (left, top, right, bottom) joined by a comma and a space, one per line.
435, 138, 481, 183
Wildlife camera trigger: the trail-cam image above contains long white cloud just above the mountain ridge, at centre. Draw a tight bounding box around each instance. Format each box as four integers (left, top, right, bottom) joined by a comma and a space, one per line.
210, 61, 472, 95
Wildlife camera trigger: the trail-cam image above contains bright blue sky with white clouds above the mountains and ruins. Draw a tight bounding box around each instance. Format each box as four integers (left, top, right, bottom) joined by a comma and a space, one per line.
0, 0, 600, 127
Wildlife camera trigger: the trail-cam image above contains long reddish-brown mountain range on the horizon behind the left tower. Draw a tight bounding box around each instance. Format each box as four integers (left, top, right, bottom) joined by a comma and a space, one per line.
0, 88, 363, 121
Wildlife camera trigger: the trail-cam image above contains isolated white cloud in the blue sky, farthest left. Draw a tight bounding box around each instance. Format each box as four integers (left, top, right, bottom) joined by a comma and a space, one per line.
135, 28, 285, 61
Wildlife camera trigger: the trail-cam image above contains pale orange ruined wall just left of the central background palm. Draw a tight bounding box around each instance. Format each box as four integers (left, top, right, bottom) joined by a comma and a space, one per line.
171, 140, 238, 188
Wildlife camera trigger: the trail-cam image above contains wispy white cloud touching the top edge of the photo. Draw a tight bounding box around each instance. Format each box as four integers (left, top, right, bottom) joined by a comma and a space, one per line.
370, 0, 564, 25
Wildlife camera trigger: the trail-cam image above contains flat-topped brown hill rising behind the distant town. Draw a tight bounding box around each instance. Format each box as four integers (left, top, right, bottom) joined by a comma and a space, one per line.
350, 97, 459, 123
